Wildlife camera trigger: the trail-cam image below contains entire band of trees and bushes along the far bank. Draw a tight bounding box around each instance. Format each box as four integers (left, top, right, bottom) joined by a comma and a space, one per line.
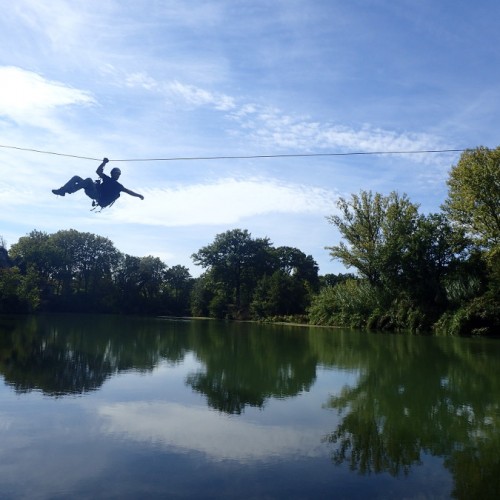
0, 147, 500, 336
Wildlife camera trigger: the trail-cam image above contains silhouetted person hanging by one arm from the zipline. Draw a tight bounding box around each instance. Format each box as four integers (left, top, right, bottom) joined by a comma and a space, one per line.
52, 158, 144, 208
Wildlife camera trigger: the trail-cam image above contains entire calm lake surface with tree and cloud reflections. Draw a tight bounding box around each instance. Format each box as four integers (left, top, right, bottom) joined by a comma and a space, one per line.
0, 316, 500, 500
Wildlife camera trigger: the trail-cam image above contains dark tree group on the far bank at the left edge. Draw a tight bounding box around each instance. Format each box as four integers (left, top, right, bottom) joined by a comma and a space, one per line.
0, 229, 193, 315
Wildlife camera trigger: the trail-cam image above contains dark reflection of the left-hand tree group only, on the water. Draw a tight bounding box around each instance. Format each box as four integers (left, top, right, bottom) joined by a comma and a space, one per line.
0, 315, 188, 396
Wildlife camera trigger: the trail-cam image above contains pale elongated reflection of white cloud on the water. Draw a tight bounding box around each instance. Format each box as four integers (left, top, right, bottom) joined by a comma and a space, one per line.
98, 402, 322, 462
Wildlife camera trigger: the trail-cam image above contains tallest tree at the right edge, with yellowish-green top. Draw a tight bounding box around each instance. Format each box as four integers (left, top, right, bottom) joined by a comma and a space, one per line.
437, 147, 500, 335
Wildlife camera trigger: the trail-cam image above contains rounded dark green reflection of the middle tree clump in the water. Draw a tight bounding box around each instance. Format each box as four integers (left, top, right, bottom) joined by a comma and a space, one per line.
187, 323, 318, 414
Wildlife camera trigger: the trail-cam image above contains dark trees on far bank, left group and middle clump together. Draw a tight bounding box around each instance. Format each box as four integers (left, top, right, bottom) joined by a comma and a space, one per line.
0, 229, 319, 321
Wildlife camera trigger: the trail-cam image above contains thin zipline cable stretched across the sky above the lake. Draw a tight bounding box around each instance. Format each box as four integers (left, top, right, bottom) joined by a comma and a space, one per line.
0, 144, 466, 162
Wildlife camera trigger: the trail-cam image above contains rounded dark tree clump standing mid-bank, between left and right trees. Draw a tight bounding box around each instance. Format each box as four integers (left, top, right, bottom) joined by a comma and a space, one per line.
192, 229, 319, 319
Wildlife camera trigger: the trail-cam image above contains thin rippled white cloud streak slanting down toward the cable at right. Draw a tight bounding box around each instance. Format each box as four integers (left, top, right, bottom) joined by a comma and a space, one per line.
122, 73, 446, 162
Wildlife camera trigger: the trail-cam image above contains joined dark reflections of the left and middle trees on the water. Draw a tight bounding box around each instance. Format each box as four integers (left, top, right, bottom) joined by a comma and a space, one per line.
0, 315, 317, 413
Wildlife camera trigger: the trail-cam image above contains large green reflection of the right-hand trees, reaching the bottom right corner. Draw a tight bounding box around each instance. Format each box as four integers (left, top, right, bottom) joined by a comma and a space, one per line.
324, 336, 500, 499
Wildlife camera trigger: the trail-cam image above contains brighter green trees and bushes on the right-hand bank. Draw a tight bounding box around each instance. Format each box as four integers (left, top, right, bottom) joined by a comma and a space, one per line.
310, 148, 500, 335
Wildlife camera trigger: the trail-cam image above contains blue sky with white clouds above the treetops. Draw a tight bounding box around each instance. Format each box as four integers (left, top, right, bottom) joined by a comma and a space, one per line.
0, 0, 500, 276
